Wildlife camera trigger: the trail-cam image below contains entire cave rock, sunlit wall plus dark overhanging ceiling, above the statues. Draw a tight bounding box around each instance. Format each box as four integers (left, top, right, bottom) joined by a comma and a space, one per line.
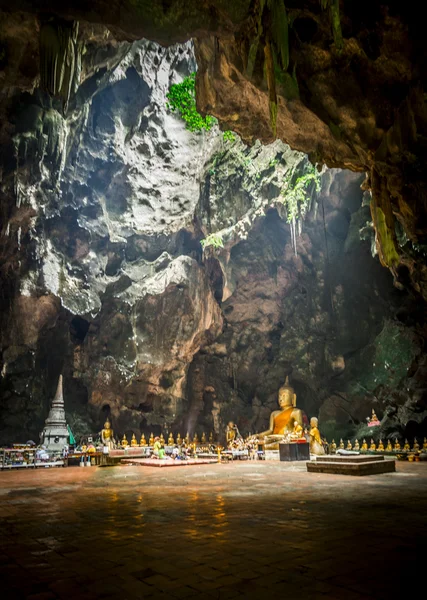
0, 7, 426, 439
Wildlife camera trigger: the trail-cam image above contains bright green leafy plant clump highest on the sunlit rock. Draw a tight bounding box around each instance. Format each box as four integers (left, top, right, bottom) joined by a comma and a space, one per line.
166, 73, 216, 132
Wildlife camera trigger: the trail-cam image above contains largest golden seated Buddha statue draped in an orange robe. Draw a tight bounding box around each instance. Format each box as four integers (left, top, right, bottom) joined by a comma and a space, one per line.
257, 377, 304, 450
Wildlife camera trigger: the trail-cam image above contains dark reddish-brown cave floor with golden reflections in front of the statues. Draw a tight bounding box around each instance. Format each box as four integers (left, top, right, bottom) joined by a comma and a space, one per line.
0, 461, 427, 600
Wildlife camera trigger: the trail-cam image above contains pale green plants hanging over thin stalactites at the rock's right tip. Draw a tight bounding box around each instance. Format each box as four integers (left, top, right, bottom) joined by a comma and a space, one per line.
281, 165, 320, 223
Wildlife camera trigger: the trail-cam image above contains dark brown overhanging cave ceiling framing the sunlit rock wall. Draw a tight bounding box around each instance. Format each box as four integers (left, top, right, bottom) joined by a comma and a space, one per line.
0, 0, 427, 298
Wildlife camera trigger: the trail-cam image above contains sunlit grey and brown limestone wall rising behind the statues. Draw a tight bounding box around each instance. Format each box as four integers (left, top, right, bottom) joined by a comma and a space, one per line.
0, 24, 426, 441
